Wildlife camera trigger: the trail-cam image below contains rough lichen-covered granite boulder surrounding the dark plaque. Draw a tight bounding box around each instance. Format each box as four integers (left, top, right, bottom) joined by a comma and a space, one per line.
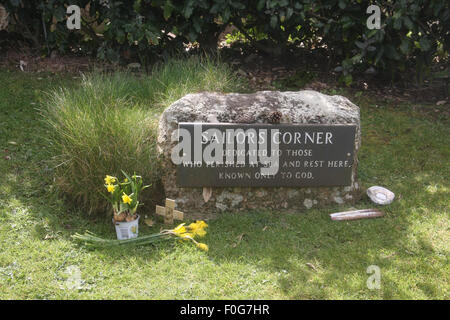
158, 90, 361, 218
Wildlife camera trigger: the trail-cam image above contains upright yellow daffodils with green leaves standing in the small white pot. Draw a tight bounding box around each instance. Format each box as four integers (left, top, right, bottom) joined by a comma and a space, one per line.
104, 171, 149, 222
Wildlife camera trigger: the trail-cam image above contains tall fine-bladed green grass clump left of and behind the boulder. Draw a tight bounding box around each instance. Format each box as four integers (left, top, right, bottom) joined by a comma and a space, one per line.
42, 58, 246, 213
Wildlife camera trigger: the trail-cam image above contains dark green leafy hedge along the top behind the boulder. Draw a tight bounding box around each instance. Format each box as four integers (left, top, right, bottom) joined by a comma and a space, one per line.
5, 0, 450, 76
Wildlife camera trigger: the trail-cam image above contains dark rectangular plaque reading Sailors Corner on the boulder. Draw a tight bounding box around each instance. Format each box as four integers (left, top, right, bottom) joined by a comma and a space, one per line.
176, 122, 357, 187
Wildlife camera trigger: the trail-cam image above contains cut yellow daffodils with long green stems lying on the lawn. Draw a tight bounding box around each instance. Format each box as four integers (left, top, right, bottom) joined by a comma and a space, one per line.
72, 221, 208, 251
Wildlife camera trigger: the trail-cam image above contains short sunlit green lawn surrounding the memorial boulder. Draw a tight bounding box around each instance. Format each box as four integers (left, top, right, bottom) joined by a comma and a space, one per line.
0, 71, 450, 299
